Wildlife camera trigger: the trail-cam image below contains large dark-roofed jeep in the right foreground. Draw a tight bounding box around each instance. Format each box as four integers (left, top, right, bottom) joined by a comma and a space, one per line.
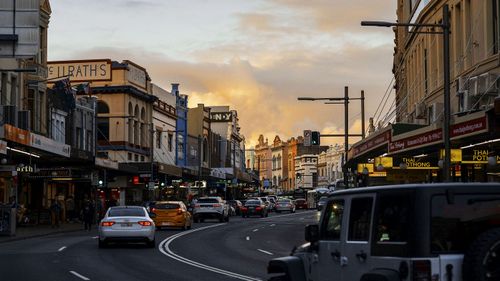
268, 182, 500, 281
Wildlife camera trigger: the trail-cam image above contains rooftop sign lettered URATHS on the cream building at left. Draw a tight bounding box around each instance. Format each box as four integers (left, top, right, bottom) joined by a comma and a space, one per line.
47, 60, 111, 82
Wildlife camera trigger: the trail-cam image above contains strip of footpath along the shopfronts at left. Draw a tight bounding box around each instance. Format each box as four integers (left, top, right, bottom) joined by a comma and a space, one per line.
0, 223, 86, 243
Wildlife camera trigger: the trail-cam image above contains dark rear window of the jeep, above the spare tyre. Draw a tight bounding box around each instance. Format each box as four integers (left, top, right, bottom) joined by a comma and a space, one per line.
430, 193, 500, 253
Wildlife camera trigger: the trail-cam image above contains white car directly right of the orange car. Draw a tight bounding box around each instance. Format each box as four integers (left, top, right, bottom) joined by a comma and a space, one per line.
193, 196, 229, 222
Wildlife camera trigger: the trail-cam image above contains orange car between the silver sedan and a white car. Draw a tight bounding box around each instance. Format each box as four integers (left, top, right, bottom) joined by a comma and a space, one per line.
151, 201, 193, 230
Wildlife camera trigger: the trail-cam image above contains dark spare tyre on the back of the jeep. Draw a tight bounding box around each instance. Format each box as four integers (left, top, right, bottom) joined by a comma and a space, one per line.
463, 228, 500, 281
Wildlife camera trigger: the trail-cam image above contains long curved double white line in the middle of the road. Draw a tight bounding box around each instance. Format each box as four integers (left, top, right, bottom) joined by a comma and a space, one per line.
158, 224, 261, 281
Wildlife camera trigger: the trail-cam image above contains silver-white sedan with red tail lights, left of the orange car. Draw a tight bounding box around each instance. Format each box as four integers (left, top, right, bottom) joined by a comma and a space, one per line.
97, 206, 156, 248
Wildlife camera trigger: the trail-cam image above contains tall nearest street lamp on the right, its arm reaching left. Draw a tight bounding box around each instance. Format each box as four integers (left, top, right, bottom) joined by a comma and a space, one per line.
361, 4, 451, 182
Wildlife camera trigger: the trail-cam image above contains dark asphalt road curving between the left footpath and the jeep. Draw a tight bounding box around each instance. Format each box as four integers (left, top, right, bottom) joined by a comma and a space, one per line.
0, 211, 318, 281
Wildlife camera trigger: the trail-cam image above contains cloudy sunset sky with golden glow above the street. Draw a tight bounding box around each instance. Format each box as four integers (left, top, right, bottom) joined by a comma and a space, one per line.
48, 0, 397, 147
